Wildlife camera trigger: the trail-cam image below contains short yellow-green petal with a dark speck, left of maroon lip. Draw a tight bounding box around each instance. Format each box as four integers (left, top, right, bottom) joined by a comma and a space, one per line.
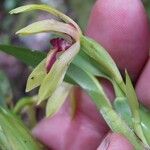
26, 59, 46, 92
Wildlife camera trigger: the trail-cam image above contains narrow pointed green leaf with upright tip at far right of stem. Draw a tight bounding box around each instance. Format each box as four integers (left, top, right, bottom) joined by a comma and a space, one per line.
126, 72, 148, 146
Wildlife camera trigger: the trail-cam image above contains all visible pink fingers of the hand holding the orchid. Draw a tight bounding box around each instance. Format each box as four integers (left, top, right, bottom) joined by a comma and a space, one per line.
33, 0, 150, 150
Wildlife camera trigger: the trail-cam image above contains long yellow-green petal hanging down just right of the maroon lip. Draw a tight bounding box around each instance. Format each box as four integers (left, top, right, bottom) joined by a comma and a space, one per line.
38, 42, 80, 103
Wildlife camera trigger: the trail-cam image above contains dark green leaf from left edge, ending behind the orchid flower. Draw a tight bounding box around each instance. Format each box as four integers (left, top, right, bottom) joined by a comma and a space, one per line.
0, 45, 46, 67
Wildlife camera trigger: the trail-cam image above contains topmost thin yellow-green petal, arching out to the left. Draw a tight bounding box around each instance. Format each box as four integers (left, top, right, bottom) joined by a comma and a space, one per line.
10, 4, 81, 33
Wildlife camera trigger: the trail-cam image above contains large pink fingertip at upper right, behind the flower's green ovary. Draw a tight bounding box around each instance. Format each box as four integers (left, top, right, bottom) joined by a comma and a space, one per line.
87, 0, 149, 80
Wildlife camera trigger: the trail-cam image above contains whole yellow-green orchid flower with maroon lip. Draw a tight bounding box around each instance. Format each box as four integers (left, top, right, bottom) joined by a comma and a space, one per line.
10, 5, 81, 103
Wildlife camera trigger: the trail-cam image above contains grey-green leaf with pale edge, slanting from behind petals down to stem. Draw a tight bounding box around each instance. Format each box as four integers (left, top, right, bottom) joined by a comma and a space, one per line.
67, 64, 111, 108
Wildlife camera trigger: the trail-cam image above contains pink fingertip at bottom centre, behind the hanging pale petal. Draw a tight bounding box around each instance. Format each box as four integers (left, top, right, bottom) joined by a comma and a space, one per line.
33, 91, 108, 150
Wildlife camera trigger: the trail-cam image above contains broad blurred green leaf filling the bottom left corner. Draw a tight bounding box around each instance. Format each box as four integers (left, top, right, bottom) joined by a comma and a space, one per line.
0, 108, 42, 150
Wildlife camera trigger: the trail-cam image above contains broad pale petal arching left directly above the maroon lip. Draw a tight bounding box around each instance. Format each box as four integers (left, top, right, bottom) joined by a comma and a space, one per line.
16, 19, 79, 40
